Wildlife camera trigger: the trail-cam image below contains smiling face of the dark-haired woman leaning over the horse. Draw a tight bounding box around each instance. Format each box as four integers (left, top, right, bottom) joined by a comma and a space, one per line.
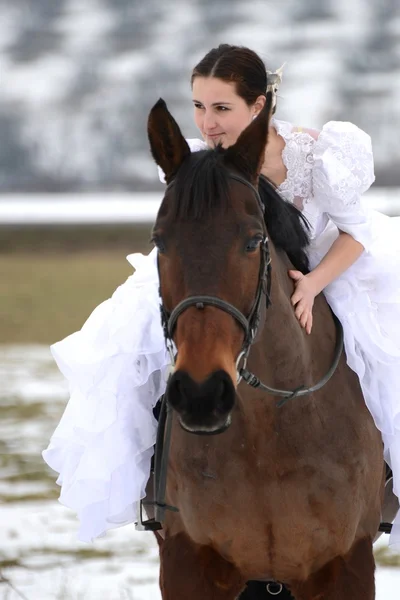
192, 77, 262, 148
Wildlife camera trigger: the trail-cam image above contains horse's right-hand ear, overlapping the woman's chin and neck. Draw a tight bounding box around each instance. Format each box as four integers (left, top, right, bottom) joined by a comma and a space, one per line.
225, 92, 272, 184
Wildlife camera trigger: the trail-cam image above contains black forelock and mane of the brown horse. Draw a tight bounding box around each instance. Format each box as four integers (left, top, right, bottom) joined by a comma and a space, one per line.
170, 146, 310, 273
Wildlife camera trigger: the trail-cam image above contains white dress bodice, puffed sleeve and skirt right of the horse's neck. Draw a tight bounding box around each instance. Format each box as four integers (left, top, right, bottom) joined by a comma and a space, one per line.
277, 121, 400, 546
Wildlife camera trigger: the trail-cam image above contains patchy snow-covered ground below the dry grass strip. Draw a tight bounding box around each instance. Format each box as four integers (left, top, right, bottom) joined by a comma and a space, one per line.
0, 346, 400, 600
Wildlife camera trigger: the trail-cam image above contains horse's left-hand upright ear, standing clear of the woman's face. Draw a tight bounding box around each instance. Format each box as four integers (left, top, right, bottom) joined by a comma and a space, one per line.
147, 98, 190, 183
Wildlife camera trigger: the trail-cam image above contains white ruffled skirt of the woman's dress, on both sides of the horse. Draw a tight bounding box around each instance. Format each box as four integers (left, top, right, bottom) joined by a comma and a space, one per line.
43, 213, 400, 544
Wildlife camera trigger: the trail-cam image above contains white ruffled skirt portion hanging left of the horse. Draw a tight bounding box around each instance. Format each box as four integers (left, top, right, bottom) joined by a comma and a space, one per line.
43, 250, 170, 541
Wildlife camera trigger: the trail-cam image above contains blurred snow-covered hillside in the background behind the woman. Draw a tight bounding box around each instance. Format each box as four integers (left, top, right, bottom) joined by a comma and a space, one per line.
0, 0, 400, 189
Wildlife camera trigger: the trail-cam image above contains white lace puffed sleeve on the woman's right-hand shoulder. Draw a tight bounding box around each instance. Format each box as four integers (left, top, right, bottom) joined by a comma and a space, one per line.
312, 121, 375, 251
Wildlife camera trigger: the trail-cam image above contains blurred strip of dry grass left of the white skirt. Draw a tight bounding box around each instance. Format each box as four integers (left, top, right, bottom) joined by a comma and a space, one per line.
0, 249, 133, 344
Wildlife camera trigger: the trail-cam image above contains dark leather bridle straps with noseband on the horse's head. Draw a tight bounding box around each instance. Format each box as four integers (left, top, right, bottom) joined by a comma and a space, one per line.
159, 173, 271, 383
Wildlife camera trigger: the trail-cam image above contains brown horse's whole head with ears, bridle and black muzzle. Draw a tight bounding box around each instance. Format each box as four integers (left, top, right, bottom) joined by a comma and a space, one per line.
148, 95, 271, 433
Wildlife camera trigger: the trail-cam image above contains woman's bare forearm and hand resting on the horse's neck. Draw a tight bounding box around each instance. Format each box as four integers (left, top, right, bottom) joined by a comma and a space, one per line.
289, 231, 364, 333
